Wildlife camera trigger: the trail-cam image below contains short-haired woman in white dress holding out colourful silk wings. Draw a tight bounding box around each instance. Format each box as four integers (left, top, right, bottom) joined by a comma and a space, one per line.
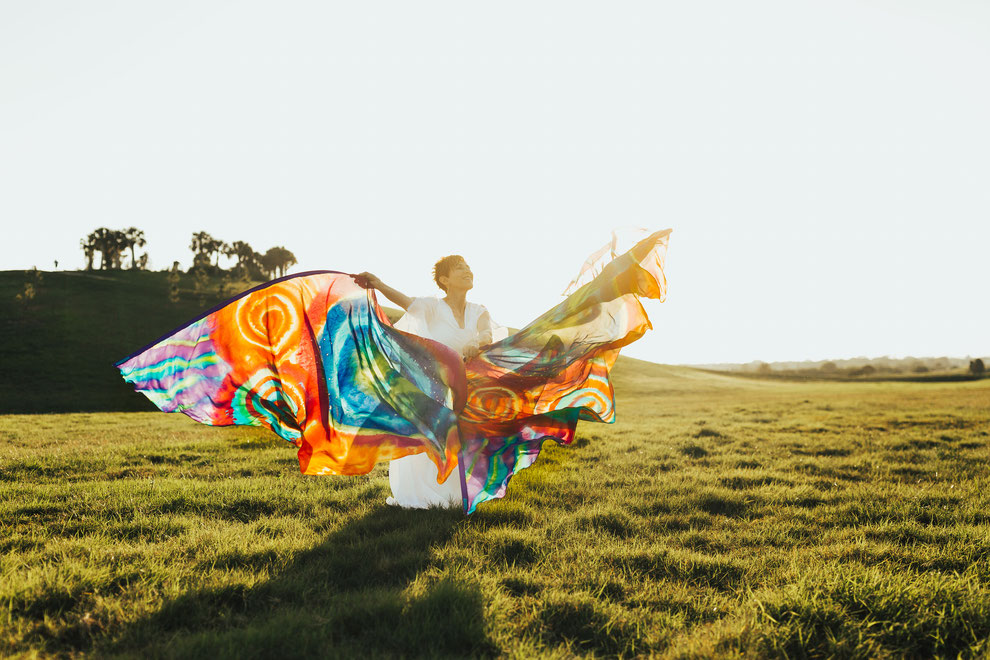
354, 254, 494, 509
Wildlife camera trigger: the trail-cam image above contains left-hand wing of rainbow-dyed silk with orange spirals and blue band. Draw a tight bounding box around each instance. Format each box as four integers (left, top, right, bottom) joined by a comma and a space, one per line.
117, 271, 465, 477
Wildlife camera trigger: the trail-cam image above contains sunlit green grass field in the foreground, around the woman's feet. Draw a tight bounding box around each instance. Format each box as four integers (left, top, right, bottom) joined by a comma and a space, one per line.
0, 360, 990, 658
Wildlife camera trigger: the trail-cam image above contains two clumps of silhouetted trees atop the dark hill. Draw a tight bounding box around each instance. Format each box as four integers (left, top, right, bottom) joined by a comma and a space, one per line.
79, 227, 297, 280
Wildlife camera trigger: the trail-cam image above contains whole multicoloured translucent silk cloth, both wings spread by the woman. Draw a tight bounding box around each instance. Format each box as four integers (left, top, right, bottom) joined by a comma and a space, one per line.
117, 229, 670, 513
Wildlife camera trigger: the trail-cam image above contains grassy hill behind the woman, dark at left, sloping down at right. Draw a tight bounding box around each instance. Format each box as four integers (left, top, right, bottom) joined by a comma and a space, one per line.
0, 271, 736, 413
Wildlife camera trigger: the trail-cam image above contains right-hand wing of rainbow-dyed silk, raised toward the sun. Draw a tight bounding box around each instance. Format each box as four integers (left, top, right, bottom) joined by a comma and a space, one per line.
460, 229, 670, 513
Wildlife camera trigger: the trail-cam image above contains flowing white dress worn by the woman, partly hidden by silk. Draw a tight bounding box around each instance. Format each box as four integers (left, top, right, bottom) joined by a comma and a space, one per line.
388, 298, 493, 509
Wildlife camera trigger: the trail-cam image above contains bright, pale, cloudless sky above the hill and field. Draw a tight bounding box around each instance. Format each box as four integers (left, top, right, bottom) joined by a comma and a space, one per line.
0, 0, 990, 363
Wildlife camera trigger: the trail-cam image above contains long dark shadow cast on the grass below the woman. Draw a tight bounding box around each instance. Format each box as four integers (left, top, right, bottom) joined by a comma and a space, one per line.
103, 507, 497, 658
